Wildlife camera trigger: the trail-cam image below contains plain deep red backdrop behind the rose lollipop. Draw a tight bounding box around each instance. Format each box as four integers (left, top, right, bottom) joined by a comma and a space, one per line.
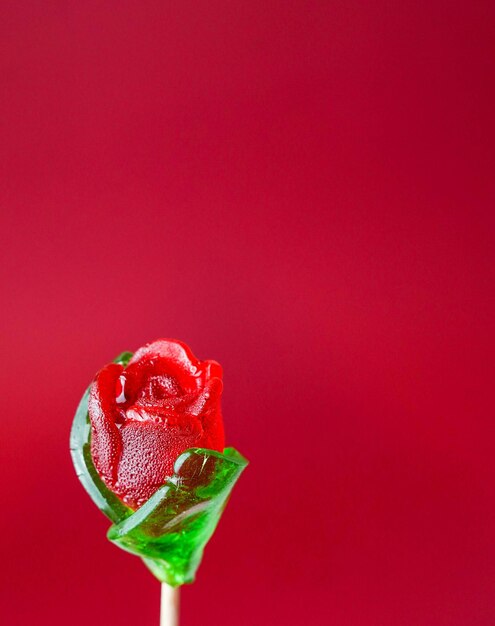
0, 0, 495, 626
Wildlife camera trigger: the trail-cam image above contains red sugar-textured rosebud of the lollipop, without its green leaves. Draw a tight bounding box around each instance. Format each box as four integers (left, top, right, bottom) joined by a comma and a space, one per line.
89, 339, 224, 510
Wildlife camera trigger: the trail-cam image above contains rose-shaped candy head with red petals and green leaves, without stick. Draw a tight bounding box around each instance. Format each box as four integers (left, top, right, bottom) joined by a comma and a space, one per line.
71, 339, 247, 587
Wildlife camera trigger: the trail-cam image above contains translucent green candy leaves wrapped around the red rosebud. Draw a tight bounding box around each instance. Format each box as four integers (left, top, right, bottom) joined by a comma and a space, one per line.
70, 352, 248, 587
